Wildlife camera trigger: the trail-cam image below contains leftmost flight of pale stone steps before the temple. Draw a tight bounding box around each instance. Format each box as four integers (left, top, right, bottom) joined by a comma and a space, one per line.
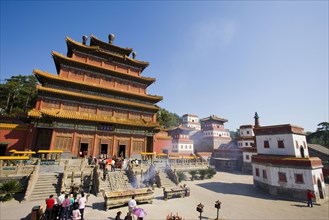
29, 173, 63, 201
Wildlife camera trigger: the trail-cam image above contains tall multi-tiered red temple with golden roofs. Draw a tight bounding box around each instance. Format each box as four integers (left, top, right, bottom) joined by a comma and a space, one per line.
28, 34, 162, 156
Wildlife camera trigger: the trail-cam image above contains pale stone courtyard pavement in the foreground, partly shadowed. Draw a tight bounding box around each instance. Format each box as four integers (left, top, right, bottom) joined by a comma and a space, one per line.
0, 172, 329, 220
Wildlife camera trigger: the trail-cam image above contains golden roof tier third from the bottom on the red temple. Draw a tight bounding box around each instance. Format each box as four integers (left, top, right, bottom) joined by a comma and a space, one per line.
33, 69, 163, 101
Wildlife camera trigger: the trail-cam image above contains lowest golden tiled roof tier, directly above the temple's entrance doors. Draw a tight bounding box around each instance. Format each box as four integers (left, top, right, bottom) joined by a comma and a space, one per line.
28, 109, 159, 128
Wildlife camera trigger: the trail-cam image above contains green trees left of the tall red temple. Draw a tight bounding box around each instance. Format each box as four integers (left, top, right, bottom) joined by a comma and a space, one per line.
0, 75, 37, 116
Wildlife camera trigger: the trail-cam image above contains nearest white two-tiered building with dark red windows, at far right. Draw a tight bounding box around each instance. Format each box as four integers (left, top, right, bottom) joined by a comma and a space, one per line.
252, 124, 327, 201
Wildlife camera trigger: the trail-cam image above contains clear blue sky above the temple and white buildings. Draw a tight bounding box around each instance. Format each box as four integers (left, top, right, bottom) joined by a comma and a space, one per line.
0, 1, 328, 131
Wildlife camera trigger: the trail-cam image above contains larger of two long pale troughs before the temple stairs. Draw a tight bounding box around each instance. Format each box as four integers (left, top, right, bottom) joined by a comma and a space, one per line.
104, 188, 154, 211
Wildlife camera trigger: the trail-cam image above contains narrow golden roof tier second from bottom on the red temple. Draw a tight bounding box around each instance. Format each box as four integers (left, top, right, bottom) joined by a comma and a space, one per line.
37, 85, 159, 110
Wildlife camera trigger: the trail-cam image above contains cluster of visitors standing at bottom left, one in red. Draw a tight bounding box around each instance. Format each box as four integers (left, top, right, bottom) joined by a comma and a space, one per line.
45, 191, 87, 220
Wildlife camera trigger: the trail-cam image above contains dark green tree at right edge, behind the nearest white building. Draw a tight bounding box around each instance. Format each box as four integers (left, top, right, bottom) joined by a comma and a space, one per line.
306, 122, 329, 148
